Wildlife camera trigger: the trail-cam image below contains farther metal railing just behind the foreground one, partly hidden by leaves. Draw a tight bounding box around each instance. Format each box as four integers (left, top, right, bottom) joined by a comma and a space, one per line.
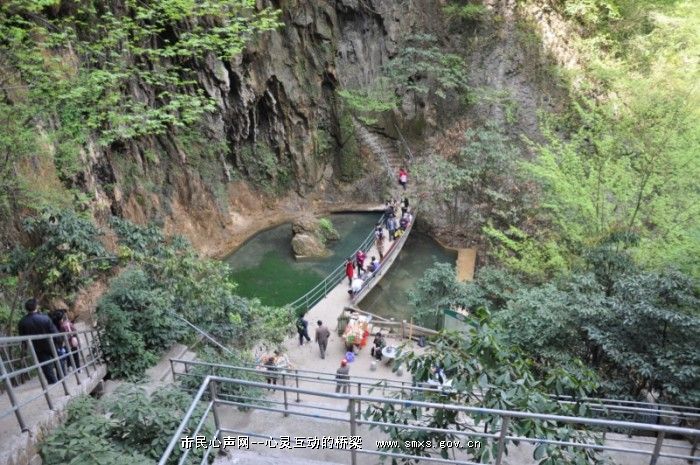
170, 359, 700, 426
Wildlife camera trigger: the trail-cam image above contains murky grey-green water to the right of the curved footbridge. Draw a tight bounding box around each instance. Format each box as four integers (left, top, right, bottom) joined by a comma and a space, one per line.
360, 230, 457, 328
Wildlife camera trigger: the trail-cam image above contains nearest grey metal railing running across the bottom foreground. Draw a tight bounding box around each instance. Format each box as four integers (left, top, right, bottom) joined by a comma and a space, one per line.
158, 375, 700, 465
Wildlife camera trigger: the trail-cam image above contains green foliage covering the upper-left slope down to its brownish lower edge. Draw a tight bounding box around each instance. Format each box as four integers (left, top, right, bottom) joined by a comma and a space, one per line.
0, 0, 280, 219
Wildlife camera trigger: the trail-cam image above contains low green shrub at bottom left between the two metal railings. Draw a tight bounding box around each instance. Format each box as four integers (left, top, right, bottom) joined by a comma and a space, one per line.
40, 384, 212, 465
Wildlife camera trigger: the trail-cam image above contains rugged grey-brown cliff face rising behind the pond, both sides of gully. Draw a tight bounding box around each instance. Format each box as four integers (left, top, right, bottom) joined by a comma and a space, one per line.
17, 0, 576, 255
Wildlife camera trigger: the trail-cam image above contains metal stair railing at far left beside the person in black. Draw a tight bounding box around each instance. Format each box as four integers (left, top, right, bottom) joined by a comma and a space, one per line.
0, 329, 103, 431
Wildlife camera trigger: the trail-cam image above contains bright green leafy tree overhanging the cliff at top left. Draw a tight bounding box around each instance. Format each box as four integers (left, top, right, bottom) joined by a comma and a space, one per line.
0, 0, 280, 145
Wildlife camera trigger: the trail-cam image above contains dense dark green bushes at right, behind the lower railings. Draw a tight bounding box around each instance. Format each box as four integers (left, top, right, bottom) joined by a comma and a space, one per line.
411, 252, 700, 405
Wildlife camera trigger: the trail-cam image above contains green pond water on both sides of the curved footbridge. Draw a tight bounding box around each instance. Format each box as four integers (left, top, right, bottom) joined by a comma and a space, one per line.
225, 213, 457, 328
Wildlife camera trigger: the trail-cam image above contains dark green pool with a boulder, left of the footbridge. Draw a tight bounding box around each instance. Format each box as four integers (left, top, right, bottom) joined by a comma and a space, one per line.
224, 213, 380, 305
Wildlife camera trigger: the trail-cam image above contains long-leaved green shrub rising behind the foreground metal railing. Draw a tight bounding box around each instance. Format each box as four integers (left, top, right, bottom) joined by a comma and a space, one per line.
366, 309, 600, 465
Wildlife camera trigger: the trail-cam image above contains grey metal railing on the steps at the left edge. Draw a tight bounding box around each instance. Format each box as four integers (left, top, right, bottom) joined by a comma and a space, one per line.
0, 330, 102, 431
